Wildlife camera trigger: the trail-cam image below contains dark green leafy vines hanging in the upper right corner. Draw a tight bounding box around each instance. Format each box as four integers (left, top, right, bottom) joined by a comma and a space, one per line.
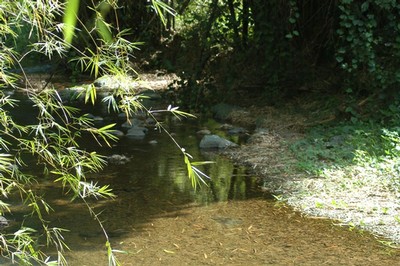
336, 0, 400, 91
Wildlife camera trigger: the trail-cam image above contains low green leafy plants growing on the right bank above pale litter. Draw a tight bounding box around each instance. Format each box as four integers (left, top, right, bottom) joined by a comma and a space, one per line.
291, 118, 400, 190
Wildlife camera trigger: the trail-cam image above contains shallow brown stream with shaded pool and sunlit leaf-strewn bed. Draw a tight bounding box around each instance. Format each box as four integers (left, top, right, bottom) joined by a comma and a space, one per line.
0, 90, 400, 266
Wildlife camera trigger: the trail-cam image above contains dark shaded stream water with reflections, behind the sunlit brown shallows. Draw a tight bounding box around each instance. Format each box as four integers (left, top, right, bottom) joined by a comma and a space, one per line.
1, 93, 266, 265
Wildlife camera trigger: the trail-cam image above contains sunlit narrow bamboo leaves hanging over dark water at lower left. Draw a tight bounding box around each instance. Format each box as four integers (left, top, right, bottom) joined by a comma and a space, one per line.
0, 87, 113, 265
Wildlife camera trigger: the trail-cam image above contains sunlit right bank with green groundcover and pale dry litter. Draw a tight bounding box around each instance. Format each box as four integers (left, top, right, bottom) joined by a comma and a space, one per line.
282, 96, 400, 244
